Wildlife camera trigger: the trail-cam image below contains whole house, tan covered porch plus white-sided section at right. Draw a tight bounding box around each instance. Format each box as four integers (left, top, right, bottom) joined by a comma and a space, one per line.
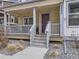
4, 0, 79, 47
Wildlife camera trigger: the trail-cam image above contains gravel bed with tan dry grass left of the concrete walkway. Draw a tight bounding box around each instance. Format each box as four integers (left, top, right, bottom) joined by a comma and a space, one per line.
0, 40, 28, 56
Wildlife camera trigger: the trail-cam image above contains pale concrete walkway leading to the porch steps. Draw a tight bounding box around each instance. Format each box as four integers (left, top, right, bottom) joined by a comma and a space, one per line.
0, 47, 48, 59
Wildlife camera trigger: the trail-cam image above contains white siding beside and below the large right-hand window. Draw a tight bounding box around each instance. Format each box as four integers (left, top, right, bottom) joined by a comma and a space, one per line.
62, 0, 79, 36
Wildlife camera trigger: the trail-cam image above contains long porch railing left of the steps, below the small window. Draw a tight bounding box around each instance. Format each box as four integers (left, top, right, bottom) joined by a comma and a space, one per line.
6, 25, 31, 34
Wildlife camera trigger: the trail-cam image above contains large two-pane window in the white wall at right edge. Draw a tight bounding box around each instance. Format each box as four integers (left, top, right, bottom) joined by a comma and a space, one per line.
68, 2, 79, 26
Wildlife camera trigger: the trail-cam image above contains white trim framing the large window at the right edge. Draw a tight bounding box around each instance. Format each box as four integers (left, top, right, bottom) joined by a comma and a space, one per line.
66, 0, 79, 27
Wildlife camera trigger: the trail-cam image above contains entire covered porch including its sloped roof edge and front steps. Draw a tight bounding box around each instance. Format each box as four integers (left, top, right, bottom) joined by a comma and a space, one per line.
4, 0, 62, 48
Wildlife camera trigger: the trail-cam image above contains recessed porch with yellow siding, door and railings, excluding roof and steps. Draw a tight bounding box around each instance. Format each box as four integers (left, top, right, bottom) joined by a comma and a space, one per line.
5, 4, 60, 35
